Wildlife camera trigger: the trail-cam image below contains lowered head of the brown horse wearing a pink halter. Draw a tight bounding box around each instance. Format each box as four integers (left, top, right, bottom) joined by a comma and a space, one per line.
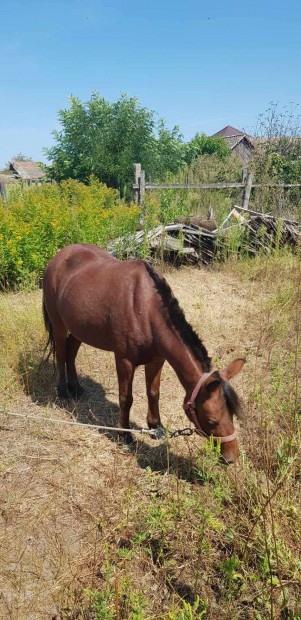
184, 359, 245, 464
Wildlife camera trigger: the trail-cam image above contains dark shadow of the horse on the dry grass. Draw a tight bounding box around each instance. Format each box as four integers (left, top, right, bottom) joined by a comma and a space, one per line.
19, 354, 200, 483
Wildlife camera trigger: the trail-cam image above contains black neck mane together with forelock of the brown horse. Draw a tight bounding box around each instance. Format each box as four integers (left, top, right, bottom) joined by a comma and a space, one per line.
143, 261, 242, 418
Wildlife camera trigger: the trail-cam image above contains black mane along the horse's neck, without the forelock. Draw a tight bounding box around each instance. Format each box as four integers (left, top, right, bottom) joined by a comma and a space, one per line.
143, 261, 211, 372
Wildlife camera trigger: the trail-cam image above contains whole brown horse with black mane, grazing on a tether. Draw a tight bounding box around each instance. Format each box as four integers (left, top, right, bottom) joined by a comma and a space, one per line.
43, 244, 245, 463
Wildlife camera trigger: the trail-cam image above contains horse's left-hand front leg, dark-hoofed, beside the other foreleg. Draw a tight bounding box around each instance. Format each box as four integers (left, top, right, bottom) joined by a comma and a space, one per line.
115, 355, 135, 443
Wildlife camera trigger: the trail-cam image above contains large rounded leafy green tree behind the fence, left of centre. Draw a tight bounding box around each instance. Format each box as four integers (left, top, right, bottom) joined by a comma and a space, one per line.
46, 93, 183, 196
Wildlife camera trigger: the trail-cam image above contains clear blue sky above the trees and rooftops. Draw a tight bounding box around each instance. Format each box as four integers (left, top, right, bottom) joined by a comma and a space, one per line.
0, 0, 301, 167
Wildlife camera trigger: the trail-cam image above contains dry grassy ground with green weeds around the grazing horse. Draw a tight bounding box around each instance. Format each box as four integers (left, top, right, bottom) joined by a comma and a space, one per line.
0, 255, 301, 620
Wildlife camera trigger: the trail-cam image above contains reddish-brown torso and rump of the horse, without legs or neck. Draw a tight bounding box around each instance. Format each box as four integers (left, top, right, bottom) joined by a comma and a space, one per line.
44, 244, 157, 358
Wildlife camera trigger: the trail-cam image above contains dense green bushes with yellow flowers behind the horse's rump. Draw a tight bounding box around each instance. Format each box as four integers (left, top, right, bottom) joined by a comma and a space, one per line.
0, 179, 139, 287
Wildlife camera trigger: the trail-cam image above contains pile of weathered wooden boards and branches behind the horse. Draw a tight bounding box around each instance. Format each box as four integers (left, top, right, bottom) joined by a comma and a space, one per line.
108, 205, 301, 265
